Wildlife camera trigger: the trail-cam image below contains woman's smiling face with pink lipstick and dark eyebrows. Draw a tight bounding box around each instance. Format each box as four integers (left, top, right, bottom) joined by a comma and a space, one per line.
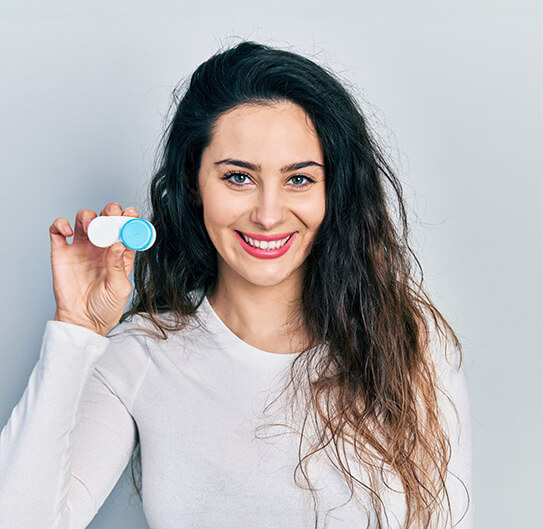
198, 102, 325, 286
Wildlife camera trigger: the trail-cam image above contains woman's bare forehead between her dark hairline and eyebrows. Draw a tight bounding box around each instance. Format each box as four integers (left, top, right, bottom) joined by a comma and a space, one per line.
209, 102, 323, 163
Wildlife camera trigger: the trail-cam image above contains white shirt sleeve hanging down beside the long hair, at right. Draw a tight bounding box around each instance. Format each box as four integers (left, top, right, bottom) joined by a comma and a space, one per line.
433, 324, 474, 529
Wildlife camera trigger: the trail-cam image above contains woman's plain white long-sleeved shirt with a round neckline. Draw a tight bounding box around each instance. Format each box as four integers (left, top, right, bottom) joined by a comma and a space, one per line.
0, 290, 473, 529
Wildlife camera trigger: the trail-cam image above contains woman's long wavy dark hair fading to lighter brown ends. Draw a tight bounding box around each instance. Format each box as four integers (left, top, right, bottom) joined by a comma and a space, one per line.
120, 41, 469, 528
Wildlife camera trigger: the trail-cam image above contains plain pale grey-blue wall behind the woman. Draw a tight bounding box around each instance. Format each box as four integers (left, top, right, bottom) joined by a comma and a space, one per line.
0, 0, 543, 529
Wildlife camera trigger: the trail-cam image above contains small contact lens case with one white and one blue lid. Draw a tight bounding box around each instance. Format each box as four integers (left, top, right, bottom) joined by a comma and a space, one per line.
87, 215, 156, 251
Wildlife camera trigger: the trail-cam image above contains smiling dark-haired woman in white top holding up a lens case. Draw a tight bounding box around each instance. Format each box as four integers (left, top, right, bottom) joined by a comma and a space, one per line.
0, 42, 472, 529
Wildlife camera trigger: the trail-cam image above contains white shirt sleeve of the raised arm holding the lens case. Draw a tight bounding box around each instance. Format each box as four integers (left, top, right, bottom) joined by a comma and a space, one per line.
0, 320, 147, 529
